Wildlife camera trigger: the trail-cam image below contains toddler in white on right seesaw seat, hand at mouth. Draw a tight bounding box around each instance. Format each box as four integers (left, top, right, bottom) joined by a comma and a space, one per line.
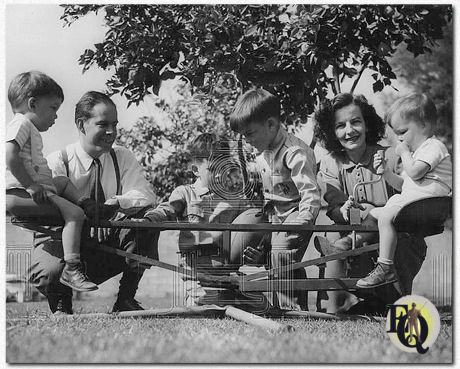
356, 94, 452, 288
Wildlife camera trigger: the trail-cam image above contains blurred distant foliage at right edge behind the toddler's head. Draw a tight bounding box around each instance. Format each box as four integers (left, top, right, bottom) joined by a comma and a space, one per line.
391, 24, 454, 152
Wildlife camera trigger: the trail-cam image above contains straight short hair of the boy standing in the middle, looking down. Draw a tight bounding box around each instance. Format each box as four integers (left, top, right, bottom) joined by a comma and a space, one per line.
230, 88, 281, 132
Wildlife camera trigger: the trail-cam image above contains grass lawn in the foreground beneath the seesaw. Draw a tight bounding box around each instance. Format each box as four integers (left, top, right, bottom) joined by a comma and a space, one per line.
6, 298, 453, 364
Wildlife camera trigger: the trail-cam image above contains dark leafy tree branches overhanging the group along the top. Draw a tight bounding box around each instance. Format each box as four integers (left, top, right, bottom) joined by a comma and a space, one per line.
62, 4, 452, 124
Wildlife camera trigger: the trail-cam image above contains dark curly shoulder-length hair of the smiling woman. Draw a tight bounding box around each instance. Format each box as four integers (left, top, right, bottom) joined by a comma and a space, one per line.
314, 93, 385, 152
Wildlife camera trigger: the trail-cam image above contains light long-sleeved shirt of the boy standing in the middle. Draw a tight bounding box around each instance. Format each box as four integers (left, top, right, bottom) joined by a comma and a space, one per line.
256, 127, 320, 223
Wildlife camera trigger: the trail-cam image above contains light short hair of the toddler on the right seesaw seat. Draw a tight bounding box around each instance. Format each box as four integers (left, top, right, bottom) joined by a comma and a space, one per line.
385, 93, 438, 127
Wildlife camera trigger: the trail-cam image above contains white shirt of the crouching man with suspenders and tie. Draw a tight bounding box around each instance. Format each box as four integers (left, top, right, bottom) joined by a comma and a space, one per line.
47, 142, 155, 209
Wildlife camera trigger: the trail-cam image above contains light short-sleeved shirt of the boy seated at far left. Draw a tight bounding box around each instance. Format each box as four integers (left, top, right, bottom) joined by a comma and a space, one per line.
5, 113, 56, 192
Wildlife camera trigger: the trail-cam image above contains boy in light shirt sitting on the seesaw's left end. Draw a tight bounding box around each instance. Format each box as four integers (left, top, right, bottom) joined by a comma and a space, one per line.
5, 71, 97, 291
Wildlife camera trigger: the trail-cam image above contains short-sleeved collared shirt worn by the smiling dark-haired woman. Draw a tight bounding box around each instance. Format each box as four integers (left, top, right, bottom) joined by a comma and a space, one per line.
318, 145, 396, 223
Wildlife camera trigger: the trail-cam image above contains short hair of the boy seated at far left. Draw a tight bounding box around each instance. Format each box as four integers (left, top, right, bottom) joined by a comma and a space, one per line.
8, 70, 64, 110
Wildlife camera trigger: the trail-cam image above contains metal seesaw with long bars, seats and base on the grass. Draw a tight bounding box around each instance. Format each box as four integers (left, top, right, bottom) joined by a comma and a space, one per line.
8, 166, 452, 330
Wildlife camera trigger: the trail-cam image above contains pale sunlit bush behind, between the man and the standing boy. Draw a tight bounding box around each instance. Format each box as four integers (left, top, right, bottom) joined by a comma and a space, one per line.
118, 80, 243, 201
